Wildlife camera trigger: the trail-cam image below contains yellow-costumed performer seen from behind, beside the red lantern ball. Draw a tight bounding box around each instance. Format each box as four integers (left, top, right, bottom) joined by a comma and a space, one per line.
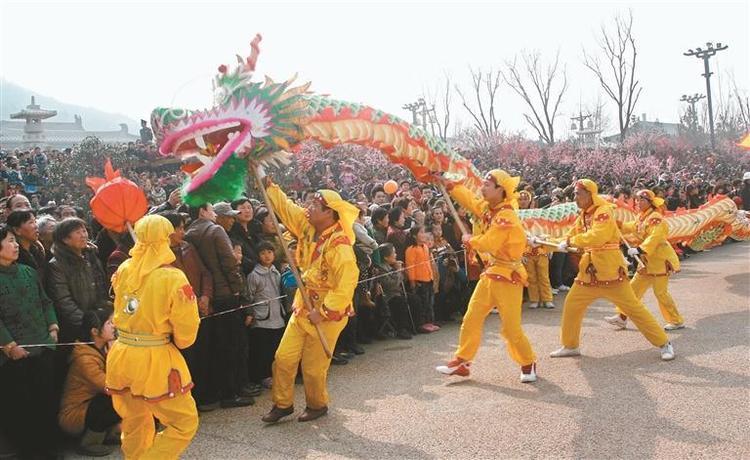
105, 215, 200, 459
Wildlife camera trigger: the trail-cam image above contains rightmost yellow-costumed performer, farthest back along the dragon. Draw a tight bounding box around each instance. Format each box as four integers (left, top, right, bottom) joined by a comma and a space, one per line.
604, 190, 685, 331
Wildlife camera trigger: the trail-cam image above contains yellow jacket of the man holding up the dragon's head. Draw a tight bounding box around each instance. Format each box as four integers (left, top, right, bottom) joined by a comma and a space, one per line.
266, 184, 359, 321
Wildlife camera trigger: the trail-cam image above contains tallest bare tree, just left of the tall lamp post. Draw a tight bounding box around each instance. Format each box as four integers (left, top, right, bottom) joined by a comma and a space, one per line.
583, 12, 643, 142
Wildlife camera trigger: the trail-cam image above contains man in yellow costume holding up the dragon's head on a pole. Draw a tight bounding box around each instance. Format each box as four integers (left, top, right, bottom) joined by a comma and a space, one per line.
263, 177, 359, 423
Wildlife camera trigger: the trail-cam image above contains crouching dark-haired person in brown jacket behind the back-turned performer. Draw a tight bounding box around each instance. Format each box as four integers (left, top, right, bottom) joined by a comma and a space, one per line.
57, 308, 120, 457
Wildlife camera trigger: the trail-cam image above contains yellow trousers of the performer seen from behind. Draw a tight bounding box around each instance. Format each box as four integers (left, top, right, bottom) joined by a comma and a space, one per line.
112, 393, 198, 460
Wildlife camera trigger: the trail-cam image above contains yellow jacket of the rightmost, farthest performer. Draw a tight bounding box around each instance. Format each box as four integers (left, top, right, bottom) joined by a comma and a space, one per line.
622, 209, 680, 276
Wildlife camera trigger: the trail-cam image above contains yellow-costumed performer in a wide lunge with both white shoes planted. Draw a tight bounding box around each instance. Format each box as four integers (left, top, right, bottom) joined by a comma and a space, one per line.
550, 179, 674, 361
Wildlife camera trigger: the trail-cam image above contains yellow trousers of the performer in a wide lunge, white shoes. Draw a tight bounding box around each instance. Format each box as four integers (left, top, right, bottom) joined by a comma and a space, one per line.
560, 282, 669, 348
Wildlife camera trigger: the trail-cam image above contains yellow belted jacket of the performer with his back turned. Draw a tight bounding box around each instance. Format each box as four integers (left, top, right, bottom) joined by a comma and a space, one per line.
106, 266, 201, 401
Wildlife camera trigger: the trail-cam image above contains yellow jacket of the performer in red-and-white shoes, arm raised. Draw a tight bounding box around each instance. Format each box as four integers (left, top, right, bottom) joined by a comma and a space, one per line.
450, 184, 528, 284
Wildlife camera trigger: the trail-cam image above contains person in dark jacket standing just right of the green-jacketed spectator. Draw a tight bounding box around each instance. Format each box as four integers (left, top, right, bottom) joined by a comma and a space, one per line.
47, 217, 109, 342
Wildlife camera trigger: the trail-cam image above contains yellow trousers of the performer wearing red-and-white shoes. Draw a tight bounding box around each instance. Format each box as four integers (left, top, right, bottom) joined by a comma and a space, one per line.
456, 276, 536, 366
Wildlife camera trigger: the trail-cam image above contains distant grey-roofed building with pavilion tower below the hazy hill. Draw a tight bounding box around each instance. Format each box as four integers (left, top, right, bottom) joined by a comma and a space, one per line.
0, 96, 140, 149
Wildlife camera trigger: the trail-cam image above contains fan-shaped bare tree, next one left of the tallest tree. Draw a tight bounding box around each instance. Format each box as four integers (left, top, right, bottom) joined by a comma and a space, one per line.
501, 51, 568, 145
